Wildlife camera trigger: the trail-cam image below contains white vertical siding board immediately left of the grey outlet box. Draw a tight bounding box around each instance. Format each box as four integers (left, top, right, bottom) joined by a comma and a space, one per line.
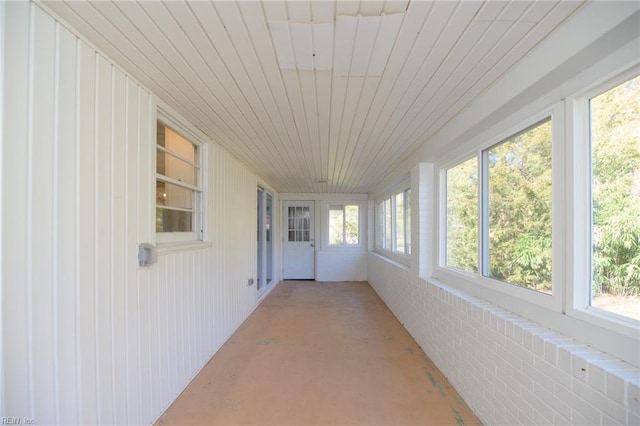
125, 79, 142, 424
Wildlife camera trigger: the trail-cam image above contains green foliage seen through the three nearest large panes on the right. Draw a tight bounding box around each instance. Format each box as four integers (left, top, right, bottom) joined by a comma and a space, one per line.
447, 77, 640, 296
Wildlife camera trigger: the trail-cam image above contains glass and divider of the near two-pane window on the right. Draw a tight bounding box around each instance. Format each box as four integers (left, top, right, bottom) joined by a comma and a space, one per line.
445, 118, 552, 294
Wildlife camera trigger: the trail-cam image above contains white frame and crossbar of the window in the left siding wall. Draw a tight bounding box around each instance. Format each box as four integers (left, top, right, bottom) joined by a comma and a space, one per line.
152, 102, 209, 247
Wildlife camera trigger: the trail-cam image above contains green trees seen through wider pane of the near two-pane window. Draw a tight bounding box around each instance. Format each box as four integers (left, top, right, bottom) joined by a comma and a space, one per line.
487, 121, 552, 293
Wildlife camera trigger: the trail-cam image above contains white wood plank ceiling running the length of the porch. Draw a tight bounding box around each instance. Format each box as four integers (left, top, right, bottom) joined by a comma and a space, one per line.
42, 0, 581, 193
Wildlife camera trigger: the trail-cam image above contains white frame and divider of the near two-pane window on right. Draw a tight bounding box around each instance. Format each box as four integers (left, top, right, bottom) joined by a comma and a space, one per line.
434, 102, 565, 311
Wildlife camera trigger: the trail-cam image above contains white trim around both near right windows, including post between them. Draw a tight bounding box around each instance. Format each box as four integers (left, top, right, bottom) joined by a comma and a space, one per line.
430, 66, 640, 365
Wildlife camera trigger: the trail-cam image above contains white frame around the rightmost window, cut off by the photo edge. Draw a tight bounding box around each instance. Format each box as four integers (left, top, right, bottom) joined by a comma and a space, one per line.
566, 64, 640, 339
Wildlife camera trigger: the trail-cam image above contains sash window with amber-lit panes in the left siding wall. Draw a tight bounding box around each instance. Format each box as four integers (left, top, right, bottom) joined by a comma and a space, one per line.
156, 121, 202, 242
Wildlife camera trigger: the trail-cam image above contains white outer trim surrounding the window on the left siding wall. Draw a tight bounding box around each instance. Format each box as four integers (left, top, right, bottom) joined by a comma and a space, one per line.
151, 100, 209, 245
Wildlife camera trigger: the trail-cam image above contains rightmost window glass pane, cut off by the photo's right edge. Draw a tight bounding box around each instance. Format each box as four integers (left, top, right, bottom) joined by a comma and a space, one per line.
590, 76, 640, 319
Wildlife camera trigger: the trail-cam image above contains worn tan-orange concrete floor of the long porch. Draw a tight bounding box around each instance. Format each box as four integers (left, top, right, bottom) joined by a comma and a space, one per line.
157, 281, 480, 426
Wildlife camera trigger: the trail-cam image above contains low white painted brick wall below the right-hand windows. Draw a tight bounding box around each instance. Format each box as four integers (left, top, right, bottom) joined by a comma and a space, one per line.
368, 253, 640, 425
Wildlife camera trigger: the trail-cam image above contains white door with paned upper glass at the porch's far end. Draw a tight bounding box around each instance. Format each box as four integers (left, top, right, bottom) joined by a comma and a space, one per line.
282, 201, 316, 280
